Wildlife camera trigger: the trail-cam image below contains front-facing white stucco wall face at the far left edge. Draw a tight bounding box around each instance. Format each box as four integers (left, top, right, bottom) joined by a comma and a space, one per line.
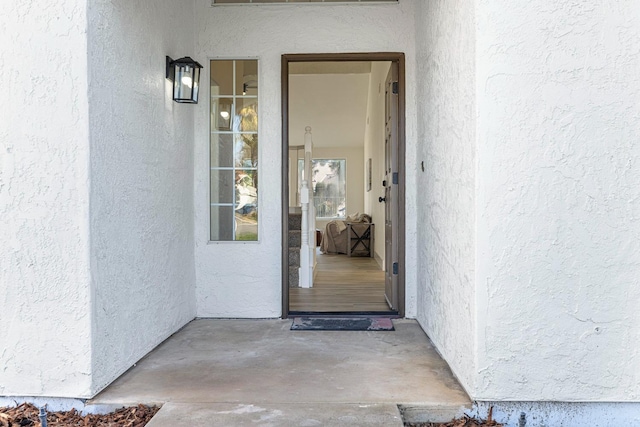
0, 0, 91, 397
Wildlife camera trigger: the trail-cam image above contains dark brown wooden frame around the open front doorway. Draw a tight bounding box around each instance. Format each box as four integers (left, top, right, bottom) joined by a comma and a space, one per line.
281, 52, 406, 319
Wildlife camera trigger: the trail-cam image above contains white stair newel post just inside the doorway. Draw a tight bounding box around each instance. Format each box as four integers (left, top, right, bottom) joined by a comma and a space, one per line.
299, 126, 316, 288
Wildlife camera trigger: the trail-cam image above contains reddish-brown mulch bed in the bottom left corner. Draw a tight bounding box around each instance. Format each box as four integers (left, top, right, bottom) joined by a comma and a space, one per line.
0, 403, 160, 427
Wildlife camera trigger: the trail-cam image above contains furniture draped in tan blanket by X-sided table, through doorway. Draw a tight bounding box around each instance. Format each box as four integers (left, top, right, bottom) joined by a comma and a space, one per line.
320, 214, 373, 255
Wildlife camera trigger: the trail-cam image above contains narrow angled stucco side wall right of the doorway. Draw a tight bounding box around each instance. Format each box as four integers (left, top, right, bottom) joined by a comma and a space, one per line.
416, 0, 476, 392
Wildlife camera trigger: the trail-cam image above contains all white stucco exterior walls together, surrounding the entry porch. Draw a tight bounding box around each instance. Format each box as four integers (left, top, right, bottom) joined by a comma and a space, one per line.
0, 0, 640, 412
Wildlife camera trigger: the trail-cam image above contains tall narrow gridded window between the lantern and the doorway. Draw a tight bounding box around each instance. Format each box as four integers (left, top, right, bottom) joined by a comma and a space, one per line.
209, 60, 258, 241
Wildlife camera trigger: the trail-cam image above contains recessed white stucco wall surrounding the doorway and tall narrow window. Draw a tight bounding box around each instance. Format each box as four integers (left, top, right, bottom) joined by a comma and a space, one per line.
195, 0, 416, 318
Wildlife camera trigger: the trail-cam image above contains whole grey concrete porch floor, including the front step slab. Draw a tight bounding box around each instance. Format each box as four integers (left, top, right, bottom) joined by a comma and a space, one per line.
88, 319, 471, 427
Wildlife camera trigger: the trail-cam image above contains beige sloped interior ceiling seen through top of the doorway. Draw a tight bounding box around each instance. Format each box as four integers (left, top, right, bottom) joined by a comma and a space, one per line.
289, 61, 371, 148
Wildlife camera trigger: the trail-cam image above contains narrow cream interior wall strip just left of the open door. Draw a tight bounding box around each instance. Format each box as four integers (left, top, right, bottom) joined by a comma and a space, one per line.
364, 62, 391, 266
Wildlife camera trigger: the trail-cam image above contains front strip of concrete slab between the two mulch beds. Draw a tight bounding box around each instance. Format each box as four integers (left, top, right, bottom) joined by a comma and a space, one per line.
147, 403, 403, 427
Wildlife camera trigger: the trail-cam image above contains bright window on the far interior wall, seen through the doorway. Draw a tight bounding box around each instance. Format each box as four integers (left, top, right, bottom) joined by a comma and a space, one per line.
298, 159, 347, 218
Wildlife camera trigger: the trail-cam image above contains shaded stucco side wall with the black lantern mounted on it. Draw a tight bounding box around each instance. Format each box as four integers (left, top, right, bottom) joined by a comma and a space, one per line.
88, 0, 198, 392
